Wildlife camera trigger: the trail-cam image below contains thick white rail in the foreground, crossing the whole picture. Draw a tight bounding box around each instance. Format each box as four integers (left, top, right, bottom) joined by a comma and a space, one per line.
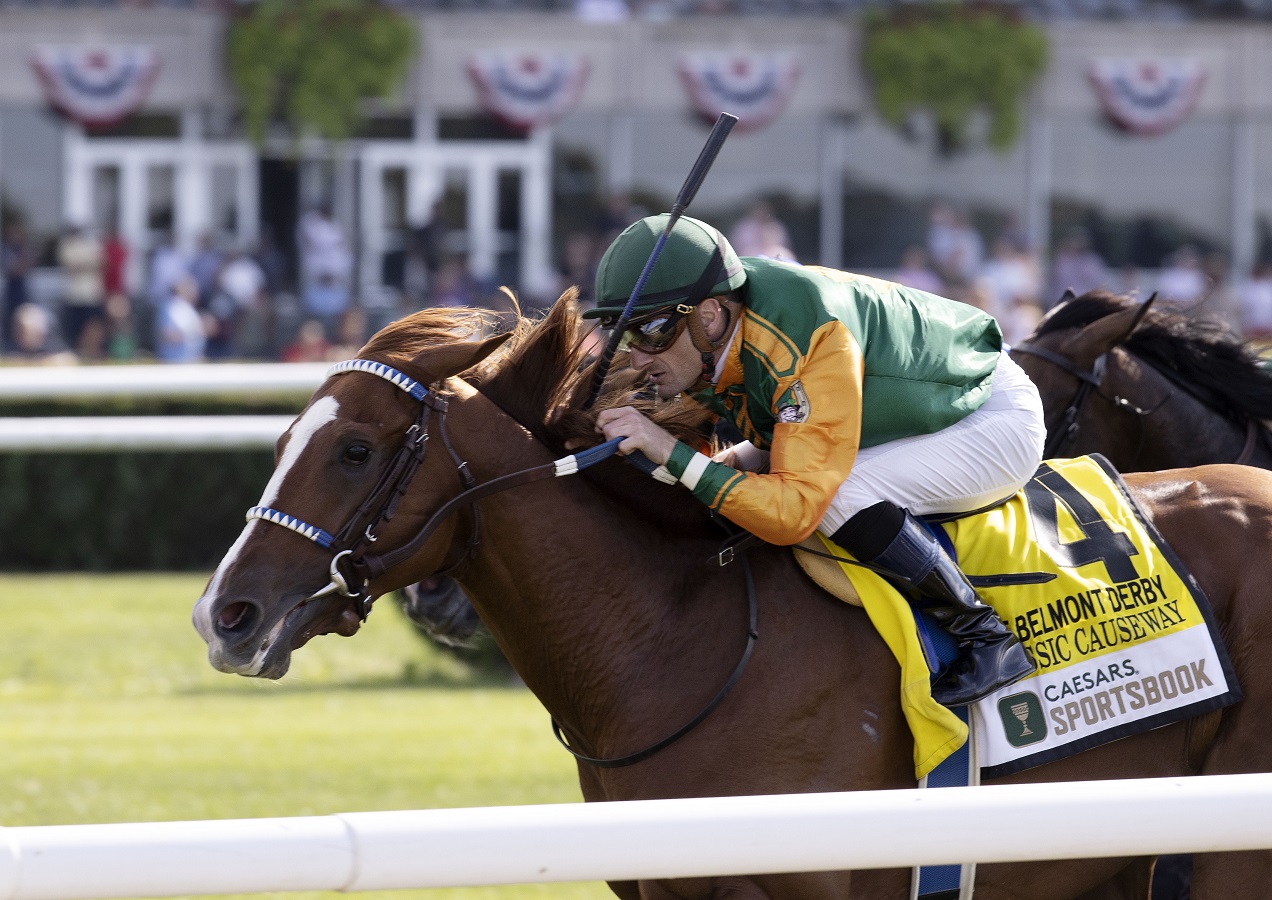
0, 774, 1272, 900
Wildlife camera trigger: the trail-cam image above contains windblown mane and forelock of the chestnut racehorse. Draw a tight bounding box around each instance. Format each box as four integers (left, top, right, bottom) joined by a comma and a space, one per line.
359, 287, 727, 534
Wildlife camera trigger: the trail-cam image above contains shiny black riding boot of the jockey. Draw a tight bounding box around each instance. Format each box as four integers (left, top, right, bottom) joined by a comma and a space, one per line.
831, 502, 1034, 707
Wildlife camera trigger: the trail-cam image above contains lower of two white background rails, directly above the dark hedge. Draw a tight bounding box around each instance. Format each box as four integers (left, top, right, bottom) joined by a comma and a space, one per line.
0, 416, 294, 453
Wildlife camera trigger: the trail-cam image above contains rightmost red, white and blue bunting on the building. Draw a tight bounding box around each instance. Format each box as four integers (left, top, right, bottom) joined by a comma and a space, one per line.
1088, 57, 1206, 136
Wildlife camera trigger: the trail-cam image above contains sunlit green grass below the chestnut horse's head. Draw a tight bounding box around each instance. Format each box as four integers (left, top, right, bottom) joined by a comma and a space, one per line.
0, 575, 611, 900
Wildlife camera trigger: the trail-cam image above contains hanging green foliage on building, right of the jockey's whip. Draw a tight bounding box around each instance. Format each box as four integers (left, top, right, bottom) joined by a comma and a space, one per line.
862, 3, 1047, 150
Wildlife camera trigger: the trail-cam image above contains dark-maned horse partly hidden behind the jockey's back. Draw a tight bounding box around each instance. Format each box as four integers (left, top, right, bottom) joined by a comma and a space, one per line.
1011, 291, 1272, 472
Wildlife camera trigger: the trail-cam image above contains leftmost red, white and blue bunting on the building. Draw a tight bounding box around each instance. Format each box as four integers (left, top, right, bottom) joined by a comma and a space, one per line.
31, 46, 159, 127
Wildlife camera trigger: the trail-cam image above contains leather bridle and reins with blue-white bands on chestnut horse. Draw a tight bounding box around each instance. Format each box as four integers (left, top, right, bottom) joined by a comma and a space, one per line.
247, 360, 759, 768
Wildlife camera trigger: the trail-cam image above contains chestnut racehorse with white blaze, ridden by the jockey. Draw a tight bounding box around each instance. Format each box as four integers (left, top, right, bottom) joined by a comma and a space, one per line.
193, 299, 1272, 900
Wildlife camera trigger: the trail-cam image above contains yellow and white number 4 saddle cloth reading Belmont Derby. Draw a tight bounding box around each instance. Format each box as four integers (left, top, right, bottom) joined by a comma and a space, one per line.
795, 456, 1241, 778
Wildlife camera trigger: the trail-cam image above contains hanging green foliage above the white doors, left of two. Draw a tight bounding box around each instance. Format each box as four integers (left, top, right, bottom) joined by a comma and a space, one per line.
225, 0, 416, 142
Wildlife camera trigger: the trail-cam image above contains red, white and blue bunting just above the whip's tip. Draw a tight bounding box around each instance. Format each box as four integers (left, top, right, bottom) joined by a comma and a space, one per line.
679, 52, 800, 131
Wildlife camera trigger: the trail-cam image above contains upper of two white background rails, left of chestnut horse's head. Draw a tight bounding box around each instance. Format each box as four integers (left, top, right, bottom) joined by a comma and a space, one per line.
0, 362, 331, 399
